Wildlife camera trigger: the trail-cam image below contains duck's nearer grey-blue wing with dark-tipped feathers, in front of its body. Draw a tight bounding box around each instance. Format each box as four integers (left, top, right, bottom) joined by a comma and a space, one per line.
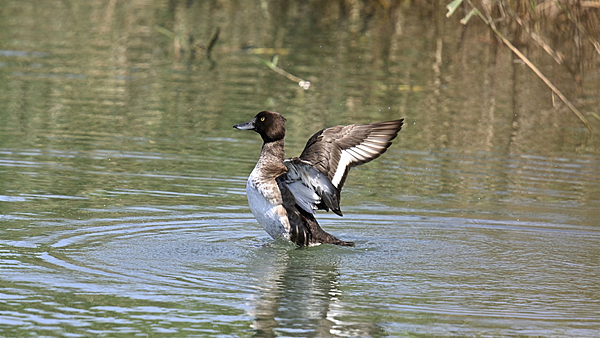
277, 158, 342, 216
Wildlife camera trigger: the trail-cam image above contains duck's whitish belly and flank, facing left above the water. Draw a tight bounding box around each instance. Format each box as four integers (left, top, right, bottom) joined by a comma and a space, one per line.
246, 166, 291, 240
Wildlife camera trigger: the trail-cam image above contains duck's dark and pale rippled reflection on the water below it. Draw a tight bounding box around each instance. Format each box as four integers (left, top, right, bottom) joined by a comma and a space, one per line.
249, 246, 381, 337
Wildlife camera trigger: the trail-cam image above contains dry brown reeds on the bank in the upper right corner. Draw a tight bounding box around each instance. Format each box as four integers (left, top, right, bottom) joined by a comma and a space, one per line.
446, 0, 600, 90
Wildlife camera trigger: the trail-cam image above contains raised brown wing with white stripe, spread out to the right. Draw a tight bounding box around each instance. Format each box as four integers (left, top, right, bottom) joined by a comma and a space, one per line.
300, 119, 404, 191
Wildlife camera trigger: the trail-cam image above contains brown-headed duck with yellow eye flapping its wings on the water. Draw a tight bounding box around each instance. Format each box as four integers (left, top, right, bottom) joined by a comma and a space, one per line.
233, 110, 404, 247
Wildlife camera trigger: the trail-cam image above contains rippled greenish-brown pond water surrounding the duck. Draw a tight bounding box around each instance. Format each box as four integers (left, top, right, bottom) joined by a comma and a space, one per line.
0, 1, 600, 337
